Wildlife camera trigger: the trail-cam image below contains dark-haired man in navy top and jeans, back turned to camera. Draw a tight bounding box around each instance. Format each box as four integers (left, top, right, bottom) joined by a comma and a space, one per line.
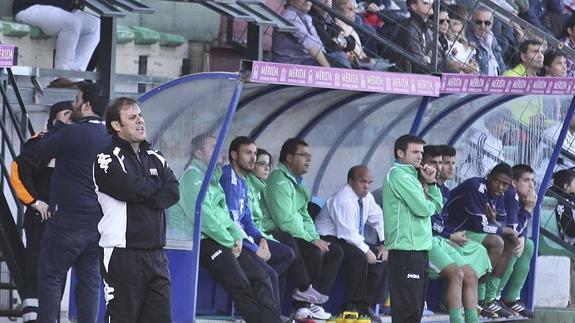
36, 84, 111, 323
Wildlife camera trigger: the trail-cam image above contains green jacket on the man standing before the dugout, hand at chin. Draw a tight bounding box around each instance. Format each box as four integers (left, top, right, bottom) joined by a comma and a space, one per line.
383, 162, 443, 251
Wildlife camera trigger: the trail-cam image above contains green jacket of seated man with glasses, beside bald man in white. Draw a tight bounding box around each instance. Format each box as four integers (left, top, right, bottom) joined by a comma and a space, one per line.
263, 163, 319, 242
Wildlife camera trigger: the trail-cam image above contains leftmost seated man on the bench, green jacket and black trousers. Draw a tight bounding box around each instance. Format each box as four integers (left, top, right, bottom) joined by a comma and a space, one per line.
170, 134, 281, 323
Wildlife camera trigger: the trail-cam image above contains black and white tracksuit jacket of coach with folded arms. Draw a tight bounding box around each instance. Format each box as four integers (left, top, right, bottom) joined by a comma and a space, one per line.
94, 136, 179, 249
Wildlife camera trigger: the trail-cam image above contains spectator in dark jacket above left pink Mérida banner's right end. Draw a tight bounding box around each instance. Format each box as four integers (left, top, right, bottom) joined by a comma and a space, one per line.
394, 0, 436, 73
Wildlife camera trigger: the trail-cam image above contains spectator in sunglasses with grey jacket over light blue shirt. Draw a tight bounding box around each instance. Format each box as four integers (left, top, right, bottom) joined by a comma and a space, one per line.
466, 6, 506, 76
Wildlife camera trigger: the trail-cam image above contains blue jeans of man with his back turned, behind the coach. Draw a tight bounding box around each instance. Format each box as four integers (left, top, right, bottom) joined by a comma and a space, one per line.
37, 223, 101, 323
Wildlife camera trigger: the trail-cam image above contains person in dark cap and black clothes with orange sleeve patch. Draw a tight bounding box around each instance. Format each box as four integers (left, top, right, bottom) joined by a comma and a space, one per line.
10, 101, 72, 322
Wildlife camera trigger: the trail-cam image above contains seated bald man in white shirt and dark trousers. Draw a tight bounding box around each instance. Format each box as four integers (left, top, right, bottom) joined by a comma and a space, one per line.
315, 165, 387, 322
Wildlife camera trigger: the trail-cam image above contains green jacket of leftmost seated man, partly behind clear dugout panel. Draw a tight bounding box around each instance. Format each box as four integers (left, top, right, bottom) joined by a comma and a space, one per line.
168, 160, 243, 248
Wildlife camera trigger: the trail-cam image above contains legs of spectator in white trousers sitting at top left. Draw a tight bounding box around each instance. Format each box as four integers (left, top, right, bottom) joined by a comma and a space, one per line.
12, 0, 100, 87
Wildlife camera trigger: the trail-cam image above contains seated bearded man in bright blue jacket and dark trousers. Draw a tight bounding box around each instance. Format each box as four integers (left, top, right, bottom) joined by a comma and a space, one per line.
220, 136, 295, 312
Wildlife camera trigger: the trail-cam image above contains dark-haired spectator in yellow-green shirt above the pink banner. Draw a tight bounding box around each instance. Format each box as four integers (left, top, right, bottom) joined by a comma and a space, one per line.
503, 39, 545, 77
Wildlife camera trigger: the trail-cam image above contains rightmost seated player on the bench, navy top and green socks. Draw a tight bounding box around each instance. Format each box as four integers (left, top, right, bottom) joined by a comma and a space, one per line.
498, 164, 537, 318
